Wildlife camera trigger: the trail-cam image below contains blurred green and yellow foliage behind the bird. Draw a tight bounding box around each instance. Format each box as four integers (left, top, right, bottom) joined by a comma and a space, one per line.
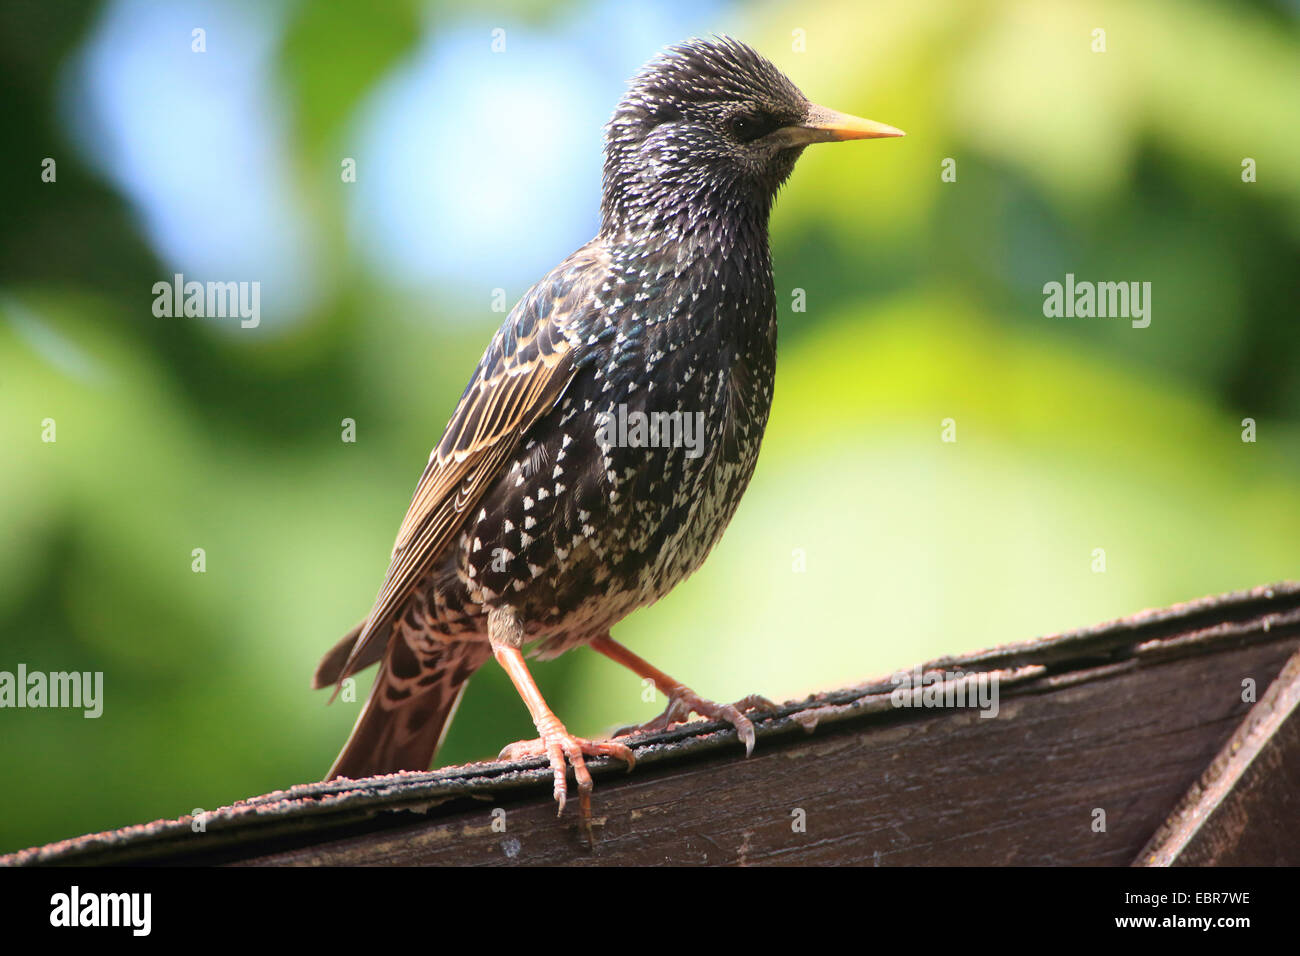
0, 0, 1300, 851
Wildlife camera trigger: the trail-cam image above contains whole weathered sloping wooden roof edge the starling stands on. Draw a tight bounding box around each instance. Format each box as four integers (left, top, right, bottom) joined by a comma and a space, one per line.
0, 584, 1300, 865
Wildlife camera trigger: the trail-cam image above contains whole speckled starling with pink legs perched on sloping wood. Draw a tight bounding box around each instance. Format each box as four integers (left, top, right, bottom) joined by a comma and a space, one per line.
313, 38, 904, 821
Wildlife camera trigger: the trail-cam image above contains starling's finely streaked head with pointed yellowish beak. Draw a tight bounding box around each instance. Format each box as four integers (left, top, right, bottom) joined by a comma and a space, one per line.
602, 36, 904, 229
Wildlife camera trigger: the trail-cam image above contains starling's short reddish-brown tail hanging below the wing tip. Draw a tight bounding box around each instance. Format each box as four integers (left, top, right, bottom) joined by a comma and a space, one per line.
312, 630, 491, 780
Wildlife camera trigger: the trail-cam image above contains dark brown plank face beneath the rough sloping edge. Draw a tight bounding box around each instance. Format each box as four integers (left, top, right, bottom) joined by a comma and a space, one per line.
236, 641, 1295, 865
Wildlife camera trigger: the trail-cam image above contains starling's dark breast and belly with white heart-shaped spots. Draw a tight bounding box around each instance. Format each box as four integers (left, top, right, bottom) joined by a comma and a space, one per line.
441, 238, 776, 652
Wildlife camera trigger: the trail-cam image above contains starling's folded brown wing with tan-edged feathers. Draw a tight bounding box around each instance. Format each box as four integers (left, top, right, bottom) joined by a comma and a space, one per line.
330, 247, 601, 679
